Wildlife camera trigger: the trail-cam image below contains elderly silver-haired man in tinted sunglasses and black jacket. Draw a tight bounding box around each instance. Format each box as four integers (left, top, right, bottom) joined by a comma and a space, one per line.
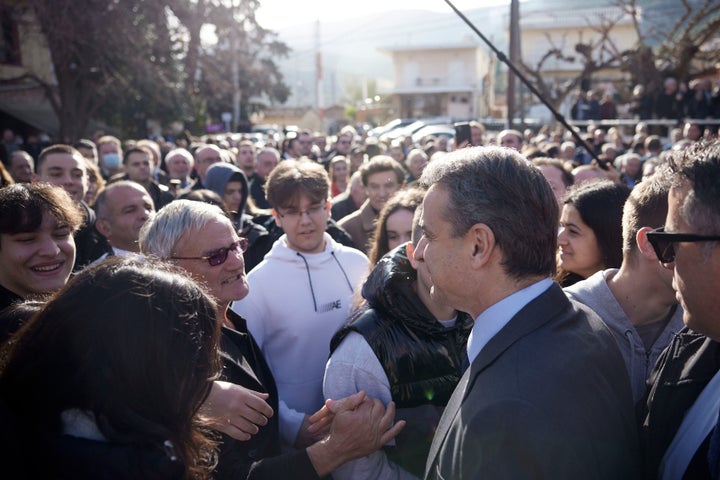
140, 200, 404, 480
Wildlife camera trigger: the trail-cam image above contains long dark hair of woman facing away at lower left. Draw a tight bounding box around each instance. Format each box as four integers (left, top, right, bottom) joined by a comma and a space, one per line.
0, 258, 220, 478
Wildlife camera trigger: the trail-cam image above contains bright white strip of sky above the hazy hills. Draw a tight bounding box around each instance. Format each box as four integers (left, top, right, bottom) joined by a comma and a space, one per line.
257, 0, 500, 30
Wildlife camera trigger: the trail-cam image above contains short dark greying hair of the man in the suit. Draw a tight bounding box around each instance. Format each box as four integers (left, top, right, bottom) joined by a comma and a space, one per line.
419, 147, 558, 279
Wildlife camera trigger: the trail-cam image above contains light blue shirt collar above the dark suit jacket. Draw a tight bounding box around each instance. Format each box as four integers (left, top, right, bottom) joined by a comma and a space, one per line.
467, 278, 553, 363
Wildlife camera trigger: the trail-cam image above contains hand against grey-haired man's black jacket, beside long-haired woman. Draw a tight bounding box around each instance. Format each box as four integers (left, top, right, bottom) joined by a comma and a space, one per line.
201, 381, 274, 441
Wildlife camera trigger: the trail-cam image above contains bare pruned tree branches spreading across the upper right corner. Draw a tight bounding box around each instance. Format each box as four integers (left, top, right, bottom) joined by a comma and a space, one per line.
520, 0, 720, 116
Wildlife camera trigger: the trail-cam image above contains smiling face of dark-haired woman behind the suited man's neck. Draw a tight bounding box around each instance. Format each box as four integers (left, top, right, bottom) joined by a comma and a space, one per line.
558, 204, 604, 278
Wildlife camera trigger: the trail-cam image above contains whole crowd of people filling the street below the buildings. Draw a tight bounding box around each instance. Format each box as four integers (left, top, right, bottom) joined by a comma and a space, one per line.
0, 114, 720, 480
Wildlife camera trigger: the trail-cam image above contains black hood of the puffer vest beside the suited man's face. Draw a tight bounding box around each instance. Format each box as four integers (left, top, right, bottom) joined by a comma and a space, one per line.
362, 245, 466, 333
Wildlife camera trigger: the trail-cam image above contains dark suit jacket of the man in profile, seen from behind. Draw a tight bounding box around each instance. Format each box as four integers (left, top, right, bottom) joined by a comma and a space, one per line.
425, 284, 640, 480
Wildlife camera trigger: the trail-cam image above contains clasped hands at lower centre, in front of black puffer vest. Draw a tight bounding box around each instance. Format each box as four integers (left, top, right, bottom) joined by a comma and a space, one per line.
307, 391, 405, 476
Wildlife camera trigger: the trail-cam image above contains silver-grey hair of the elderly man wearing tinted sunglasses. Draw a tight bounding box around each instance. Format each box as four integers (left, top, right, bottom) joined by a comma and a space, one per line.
139, 200, 234, 259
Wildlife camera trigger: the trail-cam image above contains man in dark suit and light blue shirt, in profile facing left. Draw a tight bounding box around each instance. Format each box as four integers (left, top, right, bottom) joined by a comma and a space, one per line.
415, 147, 640, 480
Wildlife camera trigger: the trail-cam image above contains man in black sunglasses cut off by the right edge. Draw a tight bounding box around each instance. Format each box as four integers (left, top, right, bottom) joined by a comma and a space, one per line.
643, 140, 720, 479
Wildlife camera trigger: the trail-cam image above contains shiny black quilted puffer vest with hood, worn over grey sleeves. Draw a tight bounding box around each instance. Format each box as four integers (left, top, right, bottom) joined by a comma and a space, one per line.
330, 245, 473, 476
